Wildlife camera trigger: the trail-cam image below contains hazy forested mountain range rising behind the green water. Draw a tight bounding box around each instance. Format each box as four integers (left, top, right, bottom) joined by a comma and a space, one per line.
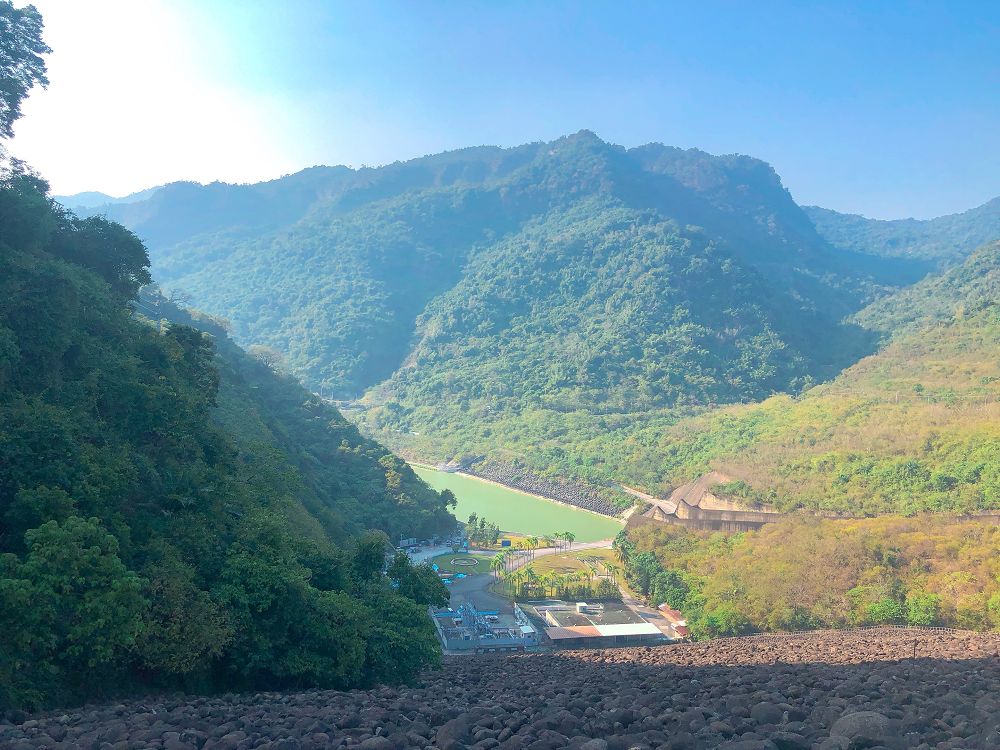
64, 131, 1000, 510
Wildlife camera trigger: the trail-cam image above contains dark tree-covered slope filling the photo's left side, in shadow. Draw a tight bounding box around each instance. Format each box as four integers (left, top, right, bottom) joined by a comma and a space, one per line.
0, 171, 453, 707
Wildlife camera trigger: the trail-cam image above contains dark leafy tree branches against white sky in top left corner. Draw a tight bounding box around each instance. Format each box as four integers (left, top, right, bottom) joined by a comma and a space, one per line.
0, 0, 52, 138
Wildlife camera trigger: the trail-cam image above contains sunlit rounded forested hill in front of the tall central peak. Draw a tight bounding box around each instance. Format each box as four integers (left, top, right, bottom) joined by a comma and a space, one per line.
369, 196, 870, 440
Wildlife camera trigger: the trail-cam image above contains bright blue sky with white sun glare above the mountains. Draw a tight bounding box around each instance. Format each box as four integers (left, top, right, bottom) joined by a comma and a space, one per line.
10, 0, 1000, 218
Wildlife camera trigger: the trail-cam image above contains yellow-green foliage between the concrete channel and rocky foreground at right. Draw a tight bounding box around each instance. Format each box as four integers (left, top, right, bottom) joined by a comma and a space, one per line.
628, 516, 1000, 635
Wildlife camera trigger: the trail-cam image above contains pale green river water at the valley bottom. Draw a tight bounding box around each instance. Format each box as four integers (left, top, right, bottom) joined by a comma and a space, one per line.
413, 466, 622, 542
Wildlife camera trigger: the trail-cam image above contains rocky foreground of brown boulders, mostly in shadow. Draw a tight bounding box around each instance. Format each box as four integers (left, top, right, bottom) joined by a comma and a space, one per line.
0, 630, 1000, 750
